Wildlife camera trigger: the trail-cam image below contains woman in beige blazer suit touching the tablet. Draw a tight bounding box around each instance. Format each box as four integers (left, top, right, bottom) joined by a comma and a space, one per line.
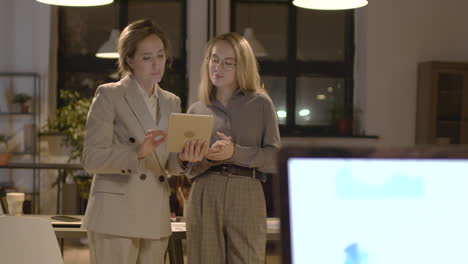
82, 20, 181, 264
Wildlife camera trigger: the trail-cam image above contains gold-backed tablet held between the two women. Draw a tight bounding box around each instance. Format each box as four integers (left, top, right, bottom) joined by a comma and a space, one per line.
167, 113, 213, 152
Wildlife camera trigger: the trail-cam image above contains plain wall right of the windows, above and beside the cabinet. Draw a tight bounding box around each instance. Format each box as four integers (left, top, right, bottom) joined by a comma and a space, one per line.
355, 0, 468, 145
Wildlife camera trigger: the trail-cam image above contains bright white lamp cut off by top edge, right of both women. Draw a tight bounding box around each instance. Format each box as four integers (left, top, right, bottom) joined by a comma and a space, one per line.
293, 0, 368, 10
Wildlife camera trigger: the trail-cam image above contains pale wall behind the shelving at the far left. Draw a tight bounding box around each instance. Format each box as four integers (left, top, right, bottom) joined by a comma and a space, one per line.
0, 0, 50, 211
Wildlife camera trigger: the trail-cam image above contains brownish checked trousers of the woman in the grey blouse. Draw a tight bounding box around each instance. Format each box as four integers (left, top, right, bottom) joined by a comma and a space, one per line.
187, 173, 266, 264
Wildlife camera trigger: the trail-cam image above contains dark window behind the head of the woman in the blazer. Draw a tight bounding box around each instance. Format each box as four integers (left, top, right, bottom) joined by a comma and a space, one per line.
57, 0, 187, 109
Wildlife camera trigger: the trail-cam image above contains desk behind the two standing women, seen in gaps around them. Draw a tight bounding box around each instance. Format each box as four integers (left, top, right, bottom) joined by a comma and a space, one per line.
29, 215, 280, 264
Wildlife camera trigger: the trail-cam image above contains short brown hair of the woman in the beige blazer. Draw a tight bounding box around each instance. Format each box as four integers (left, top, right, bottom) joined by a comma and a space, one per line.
117, 19, 171, 75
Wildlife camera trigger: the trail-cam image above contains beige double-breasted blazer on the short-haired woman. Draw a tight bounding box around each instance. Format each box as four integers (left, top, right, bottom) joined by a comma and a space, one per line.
82, 76, 182, 239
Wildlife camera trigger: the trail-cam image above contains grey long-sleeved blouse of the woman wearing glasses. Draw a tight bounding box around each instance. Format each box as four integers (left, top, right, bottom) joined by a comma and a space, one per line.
186, 89, 280, 178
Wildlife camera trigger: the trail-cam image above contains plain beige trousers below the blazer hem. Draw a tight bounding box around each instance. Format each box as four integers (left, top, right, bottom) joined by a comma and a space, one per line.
88, 231, 169, 264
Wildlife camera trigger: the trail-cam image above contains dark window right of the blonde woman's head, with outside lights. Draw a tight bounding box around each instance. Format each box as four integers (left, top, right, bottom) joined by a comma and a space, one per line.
231, 0, 354, 136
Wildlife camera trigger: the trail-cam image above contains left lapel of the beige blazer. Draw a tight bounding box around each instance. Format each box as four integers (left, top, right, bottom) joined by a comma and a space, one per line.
122, 75, 155, 131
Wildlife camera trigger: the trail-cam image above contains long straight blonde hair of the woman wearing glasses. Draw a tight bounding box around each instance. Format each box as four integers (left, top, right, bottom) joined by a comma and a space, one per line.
198, 32, 266, 104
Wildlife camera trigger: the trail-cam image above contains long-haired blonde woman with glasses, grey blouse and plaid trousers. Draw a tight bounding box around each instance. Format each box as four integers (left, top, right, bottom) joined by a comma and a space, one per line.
179, 33, 280, 264
